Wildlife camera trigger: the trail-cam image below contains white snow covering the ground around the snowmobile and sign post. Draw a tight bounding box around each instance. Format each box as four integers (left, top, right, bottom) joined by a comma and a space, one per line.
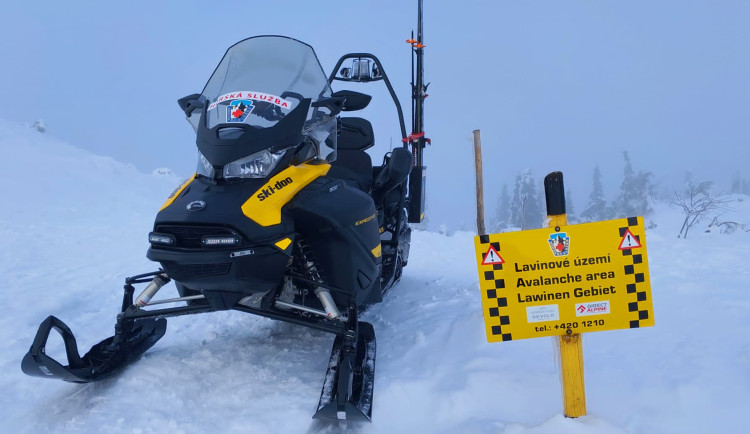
0, 122, 750, 434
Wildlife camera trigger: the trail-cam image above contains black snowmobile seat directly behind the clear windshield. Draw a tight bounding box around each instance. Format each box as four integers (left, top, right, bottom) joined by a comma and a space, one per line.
329, 118, 375, 193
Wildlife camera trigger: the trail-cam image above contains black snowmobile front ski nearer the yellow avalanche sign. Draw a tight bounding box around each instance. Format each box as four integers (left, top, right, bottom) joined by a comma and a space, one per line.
313, 320, 375, 422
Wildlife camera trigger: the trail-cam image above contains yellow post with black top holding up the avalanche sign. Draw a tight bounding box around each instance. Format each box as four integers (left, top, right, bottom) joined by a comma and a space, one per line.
544, 172, 586, 417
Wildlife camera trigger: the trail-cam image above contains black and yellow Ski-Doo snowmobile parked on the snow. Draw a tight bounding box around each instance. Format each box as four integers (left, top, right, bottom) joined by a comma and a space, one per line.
22, 2, 426, 420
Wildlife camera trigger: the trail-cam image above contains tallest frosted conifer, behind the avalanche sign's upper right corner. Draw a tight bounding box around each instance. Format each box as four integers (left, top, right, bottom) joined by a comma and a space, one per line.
611, 151, 654, 218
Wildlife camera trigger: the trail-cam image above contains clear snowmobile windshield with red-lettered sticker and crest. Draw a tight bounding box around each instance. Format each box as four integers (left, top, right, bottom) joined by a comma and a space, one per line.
188, 36, 336, 169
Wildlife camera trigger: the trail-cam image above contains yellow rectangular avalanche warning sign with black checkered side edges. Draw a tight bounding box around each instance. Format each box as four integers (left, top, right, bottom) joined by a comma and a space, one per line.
474, 217, 654, 342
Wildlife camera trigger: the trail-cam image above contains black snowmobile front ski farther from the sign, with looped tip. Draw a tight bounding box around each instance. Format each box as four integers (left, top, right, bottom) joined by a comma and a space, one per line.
21, 316, 167, 383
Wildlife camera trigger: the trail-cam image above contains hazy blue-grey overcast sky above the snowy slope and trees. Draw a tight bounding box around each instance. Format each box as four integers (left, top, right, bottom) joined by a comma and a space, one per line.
0, 0, 750, 229
